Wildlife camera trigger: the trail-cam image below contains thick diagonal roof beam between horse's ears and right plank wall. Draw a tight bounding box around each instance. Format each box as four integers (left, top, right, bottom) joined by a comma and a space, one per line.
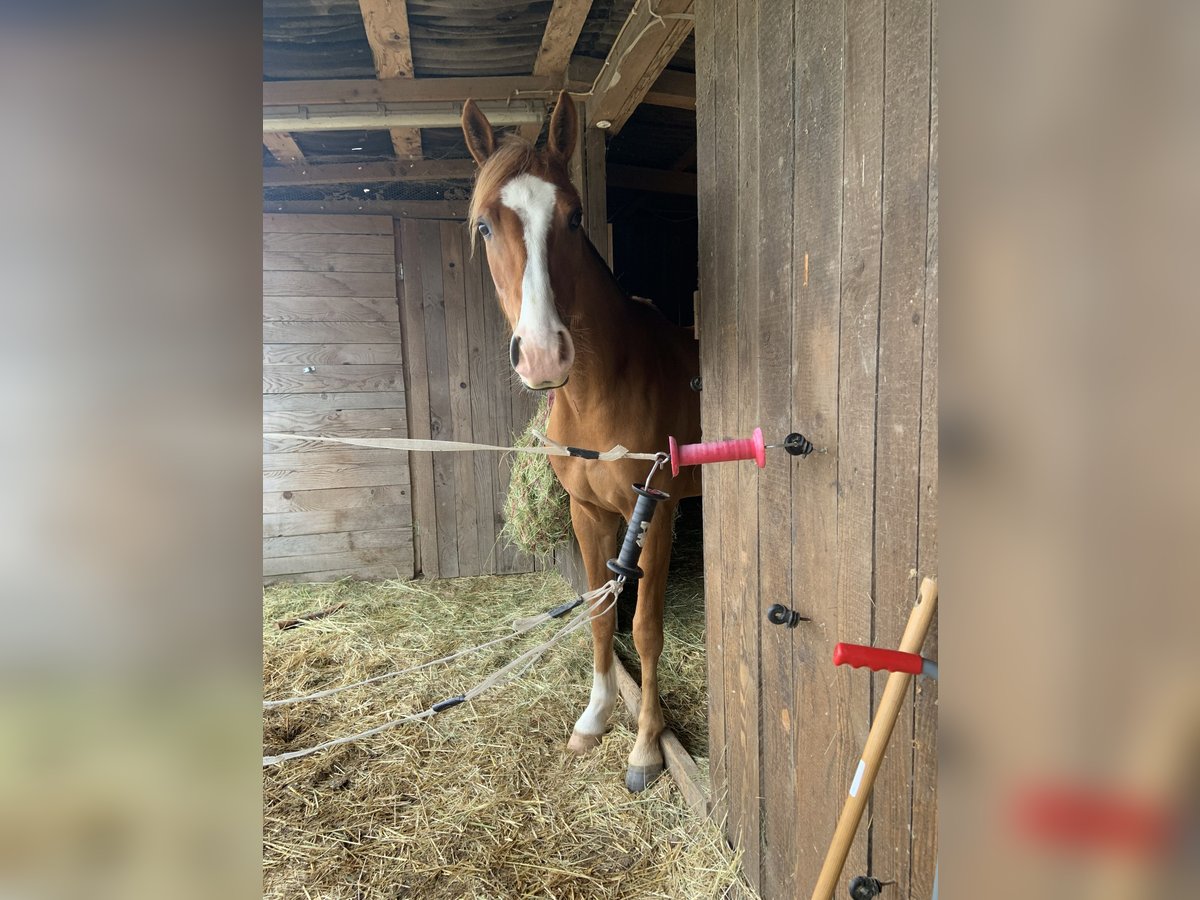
588, 0, 695, 134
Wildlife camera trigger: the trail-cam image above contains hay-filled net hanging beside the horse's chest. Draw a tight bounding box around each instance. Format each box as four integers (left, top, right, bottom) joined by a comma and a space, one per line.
502, 394, 571, 557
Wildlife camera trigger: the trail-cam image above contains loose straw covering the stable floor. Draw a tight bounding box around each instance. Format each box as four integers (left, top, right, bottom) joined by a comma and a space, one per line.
263, 572, 752, 900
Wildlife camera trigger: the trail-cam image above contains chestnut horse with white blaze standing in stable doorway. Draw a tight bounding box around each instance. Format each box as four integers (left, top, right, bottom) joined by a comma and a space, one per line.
462, 91, 700, 791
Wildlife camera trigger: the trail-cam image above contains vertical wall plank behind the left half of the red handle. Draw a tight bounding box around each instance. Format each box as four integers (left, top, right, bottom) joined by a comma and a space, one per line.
827, 0, 883, 894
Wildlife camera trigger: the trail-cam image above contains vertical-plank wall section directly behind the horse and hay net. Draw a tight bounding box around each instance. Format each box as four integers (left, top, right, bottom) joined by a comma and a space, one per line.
396, 220, 540, 577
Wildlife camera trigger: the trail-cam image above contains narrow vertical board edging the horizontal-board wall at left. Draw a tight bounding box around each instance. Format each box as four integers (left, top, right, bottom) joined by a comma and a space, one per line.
396, 222, 442, 578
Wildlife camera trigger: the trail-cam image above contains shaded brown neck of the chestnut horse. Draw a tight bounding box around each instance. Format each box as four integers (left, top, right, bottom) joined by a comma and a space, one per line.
559, 240, 641, 407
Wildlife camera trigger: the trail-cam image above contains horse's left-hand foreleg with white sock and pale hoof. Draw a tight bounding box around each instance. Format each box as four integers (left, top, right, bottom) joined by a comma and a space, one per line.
566, 498, 620, 754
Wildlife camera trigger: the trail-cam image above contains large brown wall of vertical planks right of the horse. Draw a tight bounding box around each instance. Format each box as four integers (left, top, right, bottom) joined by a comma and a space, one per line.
696, 0, 937, 900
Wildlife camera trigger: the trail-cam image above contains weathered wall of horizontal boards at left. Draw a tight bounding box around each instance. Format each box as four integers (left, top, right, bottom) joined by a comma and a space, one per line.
263, 215, 414, 582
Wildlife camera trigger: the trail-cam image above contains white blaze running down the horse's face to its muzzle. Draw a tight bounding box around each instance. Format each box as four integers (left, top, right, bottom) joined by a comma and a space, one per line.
500, 173, 570, 380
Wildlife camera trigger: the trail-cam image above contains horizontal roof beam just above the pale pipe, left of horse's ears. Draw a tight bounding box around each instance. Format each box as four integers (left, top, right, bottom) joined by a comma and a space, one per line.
263, 76, 561, 107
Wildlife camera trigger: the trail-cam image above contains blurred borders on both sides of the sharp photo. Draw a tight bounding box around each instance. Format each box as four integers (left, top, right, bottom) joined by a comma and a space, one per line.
0, 0, 1200, 898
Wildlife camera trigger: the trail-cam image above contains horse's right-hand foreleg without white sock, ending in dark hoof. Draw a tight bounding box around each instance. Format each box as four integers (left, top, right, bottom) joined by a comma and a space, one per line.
625, 504, 674, 791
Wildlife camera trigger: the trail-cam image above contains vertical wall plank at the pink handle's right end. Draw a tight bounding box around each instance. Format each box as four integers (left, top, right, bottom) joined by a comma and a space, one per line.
753, 0, 808, 896
